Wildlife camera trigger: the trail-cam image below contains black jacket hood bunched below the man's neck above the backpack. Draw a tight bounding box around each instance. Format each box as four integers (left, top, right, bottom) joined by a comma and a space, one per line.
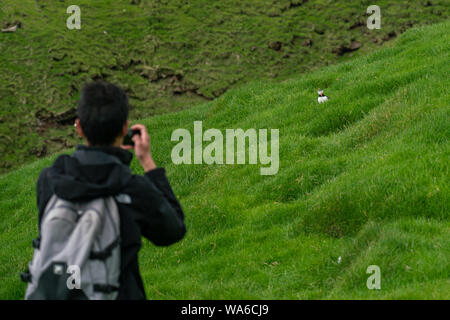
48, 146, 133, 201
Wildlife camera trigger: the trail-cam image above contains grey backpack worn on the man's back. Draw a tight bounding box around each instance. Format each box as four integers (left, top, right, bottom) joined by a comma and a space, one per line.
21, 195, 120, 300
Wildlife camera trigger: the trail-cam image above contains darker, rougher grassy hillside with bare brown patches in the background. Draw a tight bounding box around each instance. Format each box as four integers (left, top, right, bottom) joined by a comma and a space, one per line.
0, 0, 450, 173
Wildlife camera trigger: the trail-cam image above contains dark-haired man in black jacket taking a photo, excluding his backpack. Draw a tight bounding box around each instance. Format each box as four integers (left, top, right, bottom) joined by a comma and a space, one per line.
33, 82, 186, 299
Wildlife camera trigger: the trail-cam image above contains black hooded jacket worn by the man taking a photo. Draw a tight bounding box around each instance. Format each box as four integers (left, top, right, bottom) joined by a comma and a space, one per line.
37, 146, 186, 299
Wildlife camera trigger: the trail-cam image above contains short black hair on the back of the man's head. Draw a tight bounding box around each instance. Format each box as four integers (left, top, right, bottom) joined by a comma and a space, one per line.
77, 81, 129, 146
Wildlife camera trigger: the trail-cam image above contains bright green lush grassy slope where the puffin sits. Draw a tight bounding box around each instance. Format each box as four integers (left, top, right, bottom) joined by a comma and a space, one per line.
0, 23, 450, 299
